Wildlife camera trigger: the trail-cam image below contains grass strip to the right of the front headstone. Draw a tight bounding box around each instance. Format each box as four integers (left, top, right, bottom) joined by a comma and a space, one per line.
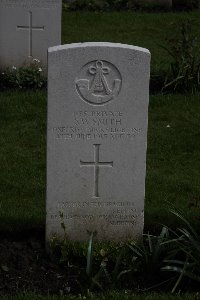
145, 95, 200, 229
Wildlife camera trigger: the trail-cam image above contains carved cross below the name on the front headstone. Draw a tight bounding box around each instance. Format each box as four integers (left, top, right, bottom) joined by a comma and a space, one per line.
80, 144, 113, 197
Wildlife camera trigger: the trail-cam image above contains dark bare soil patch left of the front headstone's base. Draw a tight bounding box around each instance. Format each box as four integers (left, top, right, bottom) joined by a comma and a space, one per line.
0, 237, 78, 296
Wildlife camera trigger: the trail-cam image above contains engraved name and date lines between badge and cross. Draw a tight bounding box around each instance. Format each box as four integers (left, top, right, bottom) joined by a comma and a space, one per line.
52, 111, 142, 140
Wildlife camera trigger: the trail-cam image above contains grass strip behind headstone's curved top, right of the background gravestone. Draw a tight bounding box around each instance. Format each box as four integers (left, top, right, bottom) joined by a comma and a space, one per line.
62, 11, 200, 72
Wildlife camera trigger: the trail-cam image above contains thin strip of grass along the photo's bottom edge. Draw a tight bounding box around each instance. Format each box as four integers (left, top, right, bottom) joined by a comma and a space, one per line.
1, 292, 200, 300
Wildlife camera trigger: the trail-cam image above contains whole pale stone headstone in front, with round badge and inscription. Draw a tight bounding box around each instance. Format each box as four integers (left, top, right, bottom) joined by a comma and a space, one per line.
46, 43, 150, 241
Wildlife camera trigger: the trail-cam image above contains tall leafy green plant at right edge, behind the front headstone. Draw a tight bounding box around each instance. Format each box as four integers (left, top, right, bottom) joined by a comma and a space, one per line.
163, 20, 200, 94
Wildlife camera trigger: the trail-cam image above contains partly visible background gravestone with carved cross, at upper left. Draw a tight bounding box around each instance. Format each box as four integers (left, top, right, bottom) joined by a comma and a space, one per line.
0, 0, 62, 69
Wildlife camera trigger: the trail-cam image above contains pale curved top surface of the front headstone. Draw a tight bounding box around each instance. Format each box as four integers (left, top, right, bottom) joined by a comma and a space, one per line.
48, 42, 150, 55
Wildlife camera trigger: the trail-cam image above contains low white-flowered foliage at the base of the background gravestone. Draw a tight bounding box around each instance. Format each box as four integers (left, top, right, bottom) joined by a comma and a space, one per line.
0, 59, 47, 89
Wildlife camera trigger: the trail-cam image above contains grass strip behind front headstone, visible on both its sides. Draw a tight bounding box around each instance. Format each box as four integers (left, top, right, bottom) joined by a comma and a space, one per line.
0, 91, 200, 232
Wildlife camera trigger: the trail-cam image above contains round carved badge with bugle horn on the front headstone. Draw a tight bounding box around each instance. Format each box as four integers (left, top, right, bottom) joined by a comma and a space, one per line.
75, 60, 122, 105
